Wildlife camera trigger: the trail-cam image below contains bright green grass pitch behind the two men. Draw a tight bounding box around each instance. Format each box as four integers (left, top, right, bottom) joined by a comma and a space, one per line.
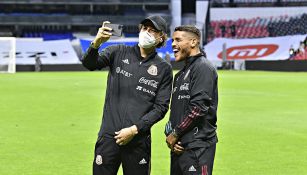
0, 71, 307, 175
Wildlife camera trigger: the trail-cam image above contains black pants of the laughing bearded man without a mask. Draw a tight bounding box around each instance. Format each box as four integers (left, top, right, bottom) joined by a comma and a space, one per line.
171, 144, 216, 175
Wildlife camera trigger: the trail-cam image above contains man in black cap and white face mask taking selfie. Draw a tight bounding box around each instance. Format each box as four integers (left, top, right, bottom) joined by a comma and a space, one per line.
82, 16, 173, 175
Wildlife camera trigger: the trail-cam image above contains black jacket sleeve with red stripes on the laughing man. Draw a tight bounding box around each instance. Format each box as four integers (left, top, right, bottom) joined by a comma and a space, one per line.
173, 63, 217, 137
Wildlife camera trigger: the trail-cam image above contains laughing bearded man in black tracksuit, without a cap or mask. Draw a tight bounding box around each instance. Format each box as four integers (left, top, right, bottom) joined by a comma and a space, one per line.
165, 26, 218, 175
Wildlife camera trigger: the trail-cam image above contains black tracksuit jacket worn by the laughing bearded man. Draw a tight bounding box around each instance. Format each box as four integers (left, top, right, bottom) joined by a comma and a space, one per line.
170, 54, 218, 148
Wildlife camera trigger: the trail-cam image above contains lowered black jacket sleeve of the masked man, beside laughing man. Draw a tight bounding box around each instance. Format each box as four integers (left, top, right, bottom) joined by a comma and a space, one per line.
136, 65, 173, 133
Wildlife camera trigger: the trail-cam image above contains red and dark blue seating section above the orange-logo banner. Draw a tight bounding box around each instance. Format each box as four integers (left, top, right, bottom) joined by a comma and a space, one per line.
208, 14, 307, 41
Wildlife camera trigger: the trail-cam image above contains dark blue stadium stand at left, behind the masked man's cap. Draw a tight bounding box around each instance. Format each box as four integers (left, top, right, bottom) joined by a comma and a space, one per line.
0, 0, 171, 39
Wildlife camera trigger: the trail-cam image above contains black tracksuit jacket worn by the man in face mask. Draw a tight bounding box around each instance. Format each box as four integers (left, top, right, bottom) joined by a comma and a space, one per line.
82, 45, 173, 142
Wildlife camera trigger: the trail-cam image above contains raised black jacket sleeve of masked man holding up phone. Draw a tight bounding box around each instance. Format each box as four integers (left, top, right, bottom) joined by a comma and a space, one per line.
81, 46, 117, 71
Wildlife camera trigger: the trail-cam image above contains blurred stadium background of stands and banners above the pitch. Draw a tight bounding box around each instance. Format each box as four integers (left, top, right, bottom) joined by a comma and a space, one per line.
0, 0, 307, 71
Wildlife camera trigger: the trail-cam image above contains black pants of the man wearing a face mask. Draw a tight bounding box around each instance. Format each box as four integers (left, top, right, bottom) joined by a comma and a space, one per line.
93, 136, 151, 175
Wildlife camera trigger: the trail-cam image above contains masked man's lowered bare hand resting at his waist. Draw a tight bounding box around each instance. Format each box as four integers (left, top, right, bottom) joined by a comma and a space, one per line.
114, 125, 138, 145
